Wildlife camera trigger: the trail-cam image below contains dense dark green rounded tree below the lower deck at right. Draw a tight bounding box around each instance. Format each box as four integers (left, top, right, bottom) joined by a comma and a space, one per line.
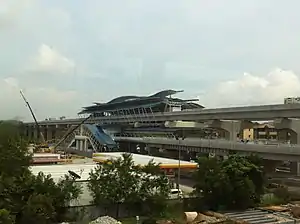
194, 155, 264, 210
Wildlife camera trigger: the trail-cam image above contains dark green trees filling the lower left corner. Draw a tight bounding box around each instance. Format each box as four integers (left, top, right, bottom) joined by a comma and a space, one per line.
0, 121, 81, 224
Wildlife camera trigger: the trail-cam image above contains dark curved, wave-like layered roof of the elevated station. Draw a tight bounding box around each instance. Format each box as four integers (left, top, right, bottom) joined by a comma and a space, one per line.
79, 90, 204, 114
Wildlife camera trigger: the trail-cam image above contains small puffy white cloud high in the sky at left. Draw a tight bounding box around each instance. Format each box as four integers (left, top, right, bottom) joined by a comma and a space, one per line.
28, 44, 75, 74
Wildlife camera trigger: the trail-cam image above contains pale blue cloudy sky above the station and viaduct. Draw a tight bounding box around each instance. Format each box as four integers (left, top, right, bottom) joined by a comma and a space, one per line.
0, 0, 300, 120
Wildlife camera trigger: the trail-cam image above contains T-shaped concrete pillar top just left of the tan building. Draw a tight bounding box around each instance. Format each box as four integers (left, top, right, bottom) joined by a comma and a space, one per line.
206, 120, 253, 141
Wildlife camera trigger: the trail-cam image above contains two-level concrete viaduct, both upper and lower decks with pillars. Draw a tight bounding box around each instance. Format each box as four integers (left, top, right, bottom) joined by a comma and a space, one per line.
25, 104, 300, 173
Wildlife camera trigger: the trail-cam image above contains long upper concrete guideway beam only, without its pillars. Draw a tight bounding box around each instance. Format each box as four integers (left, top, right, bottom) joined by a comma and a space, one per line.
26, 104, 300, 125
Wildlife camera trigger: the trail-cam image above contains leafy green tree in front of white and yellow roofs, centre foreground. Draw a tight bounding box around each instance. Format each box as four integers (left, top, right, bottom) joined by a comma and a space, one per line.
88, 154, 170, 214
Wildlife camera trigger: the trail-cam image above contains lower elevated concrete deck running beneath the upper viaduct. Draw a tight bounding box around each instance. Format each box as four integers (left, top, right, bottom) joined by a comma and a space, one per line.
115, 137, 300, 162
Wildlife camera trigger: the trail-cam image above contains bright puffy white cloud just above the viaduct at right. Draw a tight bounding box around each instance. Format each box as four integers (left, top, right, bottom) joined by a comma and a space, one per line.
199, 68, 300, 107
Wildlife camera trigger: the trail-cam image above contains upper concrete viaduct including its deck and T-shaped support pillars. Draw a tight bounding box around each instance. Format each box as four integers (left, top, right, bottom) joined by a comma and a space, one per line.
25, 104, 300, 144
